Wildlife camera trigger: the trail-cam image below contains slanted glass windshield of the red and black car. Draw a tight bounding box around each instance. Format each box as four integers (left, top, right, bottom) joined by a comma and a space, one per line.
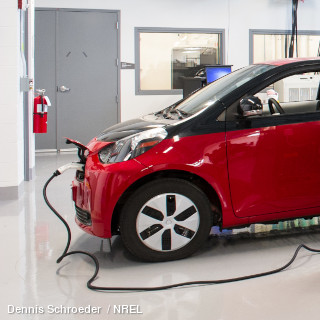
176, 64, 275, 115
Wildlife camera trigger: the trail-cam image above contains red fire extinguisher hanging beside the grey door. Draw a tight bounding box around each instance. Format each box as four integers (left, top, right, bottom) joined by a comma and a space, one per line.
33, 89, 51, 133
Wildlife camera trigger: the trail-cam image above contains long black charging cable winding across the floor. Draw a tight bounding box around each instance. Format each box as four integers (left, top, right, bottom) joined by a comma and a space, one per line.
43, 170, 320, 292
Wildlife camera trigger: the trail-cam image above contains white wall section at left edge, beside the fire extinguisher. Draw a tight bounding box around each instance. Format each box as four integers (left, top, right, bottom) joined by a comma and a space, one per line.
0, 0, 24, 199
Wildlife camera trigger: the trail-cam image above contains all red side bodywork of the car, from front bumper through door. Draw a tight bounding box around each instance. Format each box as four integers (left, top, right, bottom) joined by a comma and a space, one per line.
73, 122, 320, 238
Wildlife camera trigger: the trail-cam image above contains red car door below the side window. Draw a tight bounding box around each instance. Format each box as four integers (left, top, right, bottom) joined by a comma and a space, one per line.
226, 72, 320, 217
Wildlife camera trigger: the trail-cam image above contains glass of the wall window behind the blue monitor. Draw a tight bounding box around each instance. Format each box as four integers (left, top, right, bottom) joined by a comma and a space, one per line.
136, 30, 223, 93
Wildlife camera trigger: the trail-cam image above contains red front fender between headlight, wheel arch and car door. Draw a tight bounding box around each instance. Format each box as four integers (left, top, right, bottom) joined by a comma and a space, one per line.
137, 132, 238, 227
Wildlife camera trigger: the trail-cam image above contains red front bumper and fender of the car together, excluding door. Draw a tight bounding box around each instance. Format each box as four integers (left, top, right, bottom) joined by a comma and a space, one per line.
72, 133, 248, 238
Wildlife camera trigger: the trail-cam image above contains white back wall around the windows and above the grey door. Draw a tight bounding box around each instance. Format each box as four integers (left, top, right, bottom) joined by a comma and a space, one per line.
35, 0, 320, 121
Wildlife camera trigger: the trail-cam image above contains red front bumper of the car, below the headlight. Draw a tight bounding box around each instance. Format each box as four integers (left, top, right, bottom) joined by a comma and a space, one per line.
72, 158, 149, 238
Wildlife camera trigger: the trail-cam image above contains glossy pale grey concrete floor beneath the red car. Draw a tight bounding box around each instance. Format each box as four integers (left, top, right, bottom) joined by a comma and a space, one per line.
0, 153, 320, 320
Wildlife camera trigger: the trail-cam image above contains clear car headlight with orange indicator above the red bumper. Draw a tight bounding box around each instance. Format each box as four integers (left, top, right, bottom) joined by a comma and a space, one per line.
99, 128, 168, 163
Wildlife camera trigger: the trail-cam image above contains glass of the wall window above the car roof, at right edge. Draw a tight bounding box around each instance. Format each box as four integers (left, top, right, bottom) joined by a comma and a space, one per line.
251, 32, 320, 63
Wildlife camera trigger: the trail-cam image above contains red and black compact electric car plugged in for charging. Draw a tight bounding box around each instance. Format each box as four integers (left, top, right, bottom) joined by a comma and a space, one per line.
72, 58, 320, 261
